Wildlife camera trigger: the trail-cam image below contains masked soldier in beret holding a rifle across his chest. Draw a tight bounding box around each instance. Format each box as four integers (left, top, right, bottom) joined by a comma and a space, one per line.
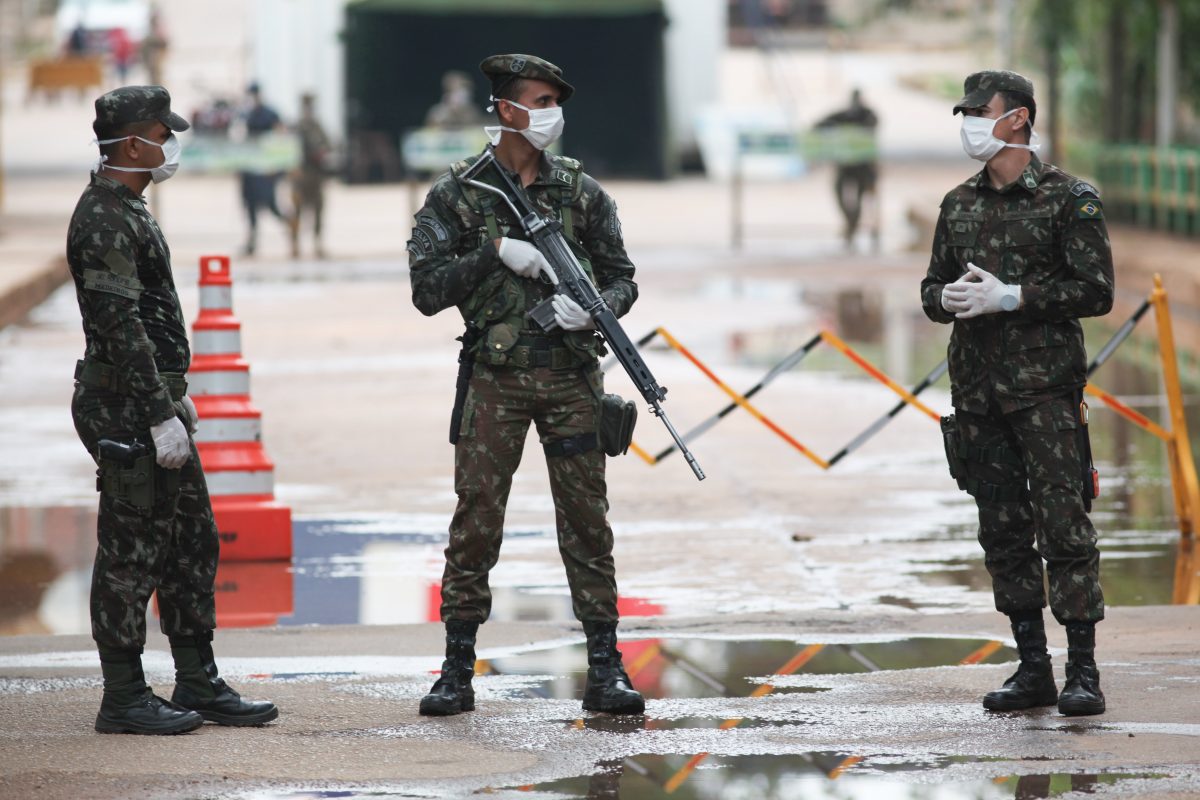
408, 55, 644, 715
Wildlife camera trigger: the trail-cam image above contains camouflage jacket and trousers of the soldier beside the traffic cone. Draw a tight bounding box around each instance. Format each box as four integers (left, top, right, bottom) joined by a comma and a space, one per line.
67, 167, 218, 652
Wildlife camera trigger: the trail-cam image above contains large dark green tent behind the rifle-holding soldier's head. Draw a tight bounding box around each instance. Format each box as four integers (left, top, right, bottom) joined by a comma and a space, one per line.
344, 0, 667, 180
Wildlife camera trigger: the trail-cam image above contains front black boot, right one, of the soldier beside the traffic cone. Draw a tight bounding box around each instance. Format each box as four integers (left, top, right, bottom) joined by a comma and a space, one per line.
168, 631, 280, 727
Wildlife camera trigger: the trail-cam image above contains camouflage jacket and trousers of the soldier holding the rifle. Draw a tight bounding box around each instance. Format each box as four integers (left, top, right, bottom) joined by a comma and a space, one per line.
408, 148, 637, 624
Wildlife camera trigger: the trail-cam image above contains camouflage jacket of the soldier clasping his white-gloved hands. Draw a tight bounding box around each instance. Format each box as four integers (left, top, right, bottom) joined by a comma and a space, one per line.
920, 156, 1114, 414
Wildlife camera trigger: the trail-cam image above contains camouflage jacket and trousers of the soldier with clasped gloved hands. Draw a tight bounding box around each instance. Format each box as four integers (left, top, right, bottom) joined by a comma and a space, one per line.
922, 153, 1114, 624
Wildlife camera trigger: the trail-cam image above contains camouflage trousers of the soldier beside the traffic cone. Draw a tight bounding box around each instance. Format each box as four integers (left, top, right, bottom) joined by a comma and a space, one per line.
71, 385, 220, 652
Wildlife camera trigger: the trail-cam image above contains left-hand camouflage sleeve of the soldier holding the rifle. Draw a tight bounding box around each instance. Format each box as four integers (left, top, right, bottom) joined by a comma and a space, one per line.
408, 188, 503, 317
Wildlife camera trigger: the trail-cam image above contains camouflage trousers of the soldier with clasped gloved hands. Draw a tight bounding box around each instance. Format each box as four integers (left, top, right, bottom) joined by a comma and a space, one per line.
954, 396, 1104, 625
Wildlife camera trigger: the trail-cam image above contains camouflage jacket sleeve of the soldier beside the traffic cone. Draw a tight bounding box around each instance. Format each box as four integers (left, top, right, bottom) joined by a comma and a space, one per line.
72, 230, 175, 425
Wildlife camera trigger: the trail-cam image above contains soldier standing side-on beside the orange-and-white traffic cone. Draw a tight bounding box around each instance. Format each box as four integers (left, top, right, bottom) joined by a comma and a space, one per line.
67, 86, 278, 734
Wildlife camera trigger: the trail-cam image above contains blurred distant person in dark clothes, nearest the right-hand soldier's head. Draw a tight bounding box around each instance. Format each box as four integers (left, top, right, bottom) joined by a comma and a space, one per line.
816, 89, 880, 251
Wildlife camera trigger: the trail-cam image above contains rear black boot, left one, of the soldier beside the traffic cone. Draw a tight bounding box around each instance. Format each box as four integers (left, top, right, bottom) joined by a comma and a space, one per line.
96, 649, 204, 735
